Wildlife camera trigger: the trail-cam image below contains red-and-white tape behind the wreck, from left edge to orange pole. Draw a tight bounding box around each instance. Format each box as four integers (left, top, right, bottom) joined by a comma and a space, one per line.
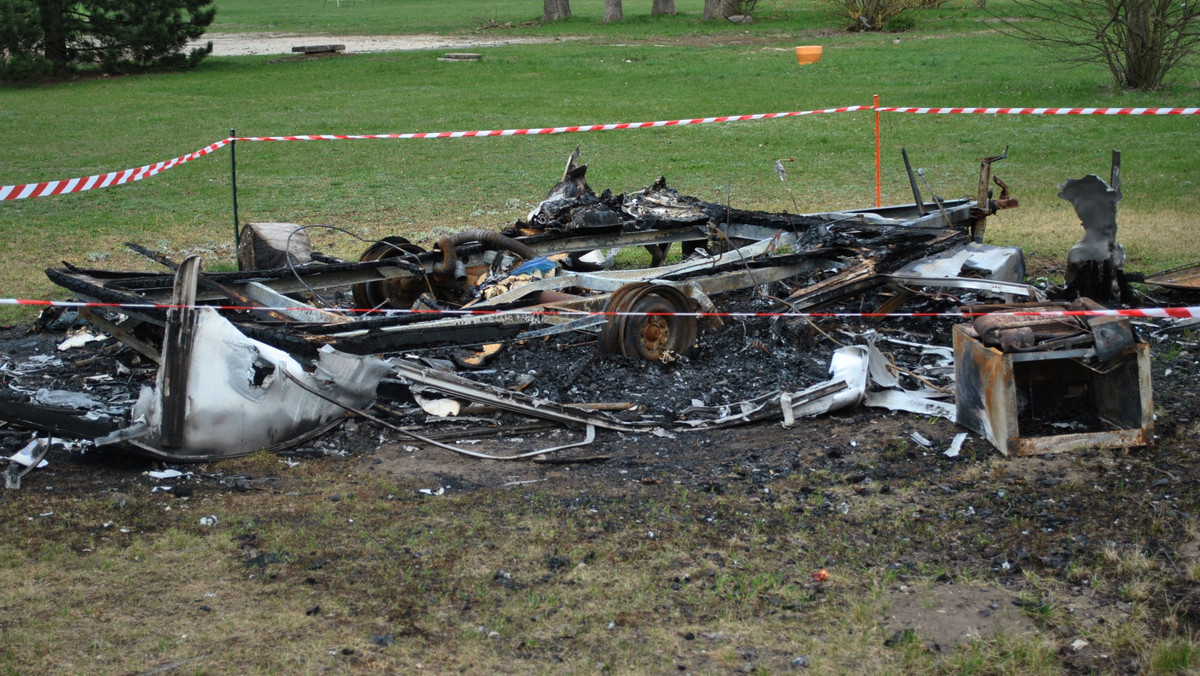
0, 106, 871, 202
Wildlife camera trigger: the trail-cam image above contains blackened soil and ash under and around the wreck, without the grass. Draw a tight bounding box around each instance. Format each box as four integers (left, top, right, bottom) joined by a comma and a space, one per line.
0, 277, 1200, 672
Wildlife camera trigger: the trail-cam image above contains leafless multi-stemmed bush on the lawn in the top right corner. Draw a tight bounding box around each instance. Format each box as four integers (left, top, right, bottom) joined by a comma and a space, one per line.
1004, 0, 1200, 90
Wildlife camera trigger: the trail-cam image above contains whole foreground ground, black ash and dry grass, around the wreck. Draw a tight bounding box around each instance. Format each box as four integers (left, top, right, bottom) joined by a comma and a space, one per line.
2, 277, 1200, 674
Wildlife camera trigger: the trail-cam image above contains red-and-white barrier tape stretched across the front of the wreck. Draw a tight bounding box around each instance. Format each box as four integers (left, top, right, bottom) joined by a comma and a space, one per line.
0, 298, 1200, 319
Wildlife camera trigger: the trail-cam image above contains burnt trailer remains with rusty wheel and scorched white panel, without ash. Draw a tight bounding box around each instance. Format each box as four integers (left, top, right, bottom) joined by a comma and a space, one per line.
25, 162, 1060, 461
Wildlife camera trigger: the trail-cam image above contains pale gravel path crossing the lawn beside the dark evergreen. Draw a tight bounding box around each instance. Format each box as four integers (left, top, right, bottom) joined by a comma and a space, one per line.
188, 32, 553, 56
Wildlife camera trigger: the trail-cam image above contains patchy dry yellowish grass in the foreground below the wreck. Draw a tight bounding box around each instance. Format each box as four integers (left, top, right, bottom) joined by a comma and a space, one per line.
0, 437, 1194, 674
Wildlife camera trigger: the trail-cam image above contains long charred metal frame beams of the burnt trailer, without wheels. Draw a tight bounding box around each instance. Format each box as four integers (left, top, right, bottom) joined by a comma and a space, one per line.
46, 187, 1020, 354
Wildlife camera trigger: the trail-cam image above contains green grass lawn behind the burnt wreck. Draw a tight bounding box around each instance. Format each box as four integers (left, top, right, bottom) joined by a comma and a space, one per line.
0, 0, 1200, 319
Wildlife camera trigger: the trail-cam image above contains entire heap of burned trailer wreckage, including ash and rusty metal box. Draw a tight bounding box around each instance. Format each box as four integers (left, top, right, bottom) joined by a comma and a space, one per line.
2, 149, 1180, 475
